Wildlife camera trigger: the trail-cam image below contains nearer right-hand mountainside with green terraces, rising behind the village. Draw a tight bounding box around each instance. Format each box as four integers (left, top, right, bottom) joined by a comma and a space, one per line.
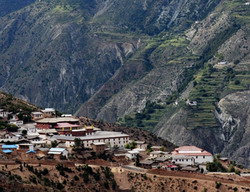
83, 0, 250, 166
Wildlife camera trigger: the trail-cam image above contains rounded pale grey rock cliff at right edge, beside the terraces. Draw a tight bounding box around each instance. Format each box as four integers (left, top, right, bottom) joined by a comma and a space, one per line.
218, 91, 250, 166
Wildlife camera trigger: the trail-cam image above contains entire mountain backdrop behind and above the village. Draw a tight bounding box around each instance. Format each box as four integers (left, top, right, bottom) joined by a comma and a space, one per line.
0, 0, 250, 165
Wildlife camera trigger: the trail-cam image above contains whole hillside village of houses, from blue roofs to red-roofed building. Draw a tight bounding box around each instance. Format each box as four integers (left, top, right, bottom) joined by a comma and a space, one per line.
0, 108, 213, 171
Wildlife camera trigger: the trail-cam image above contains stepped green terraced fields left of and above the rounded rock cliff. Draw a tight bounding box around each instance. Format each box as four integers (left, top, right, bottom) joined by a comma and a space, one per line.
187, 61, 250, 129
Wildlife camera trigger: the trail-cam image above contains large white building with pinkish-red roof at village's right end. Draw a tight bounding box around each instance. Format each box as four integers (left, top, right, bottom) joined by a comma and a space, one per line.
172, 146, 213, 164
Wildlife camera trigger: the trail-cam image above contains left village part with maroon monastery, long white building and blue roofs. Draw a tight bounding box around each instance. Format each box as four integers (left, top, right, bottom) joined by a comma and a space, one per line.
0, 108, 130, 158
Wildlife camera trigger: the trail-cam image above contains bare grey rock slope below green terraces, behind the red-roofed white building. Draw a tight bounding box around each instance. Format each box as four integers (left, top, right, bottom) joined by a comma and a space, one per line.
154, 109, 224, 153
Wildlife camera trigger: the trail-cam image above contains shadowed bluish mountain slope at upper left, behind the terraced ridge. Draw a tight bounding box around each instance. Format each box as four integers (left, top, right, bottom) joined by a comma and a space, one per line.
0, 0, 218, 114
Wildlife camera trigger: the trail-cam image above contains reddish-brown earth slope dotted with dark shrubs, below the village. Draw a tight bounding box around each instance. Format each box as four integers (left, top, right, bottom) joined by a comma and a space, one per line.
0, 163, 250, 192
